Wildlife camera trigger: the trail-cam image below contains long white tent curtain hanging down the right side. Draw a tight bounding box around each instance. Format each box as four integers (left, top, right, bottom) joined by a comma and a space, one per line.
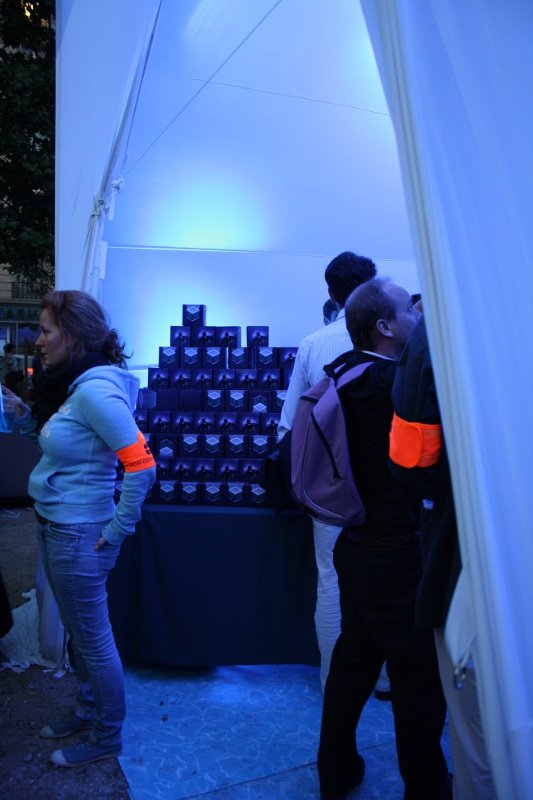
362, 0, 533, 800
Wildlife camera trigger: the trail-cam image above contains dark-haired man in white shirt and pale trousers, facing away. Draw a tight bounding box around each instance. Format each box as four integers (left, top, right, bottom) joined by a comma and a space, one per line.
278, 252, 376, 690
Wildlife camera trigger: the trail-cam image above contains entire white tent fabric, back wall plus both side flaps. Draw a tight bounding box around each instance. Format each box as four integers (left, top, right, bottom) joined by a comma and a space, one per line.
57, 0, 533, 800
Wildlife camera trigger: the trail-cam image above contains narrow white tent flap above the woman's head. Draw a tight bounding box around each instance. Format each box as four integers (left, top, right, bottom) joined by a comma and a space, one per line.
56, 0, 161, 296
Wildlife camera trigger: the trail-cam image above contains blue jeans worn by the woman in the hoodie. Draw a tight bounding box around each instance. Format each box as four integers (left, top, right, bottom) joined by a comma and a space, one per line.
37, 522, 126, 747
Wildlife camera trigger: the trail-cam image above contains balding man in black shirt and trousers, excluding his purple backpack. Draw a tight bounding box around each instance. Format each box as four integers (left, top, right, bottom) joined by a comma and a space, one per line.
318, 279, 451, 800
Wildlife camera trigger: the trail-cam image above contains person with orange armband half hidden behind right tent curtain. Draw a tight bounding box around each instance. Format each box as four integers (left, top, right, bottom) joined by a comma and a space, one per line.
390, 317, 496, 800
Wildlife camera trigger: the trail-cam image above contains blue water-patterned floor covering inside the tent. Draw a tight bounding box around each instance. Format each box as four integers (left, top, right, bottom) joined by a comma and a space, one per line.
120, 665, 448, 800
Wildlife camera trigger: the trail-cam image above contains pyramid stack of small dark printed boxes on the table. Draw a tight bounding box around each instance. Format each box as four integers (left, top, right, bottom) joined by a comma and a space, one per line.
128, 305, 297, 507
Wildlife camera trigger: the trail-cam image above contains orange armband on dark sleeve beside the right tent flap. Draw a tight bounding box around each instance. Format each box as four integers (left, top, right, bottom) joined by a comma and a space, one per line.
389, 414, 442, 469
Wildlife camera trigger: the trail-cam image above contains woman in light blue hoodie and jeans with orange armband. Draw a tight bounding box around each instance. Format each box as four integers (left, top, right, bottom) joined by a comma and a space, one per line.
4, 291, 155, 767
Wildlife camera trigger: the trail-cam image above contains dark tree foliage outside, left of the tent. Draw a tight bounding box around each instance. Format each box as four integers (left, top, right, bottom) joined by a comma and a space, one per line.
0, 0, 55, 289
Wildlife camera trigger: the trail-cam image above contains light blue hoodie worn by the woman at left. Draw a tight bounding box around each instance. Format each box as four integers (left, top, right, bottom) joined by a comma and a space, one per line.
19, 365, 155, 544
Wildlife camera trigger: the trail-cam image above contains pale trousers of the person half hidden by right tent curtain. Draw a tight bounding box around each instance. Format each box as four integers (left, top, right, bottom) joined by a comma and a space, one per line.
435, 628, 497, 800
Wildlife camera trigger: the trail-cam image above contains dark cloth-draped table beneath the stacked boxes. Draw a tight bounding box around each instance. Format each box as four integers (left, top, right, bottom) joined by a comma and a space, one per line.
108, 505, 319, 666
